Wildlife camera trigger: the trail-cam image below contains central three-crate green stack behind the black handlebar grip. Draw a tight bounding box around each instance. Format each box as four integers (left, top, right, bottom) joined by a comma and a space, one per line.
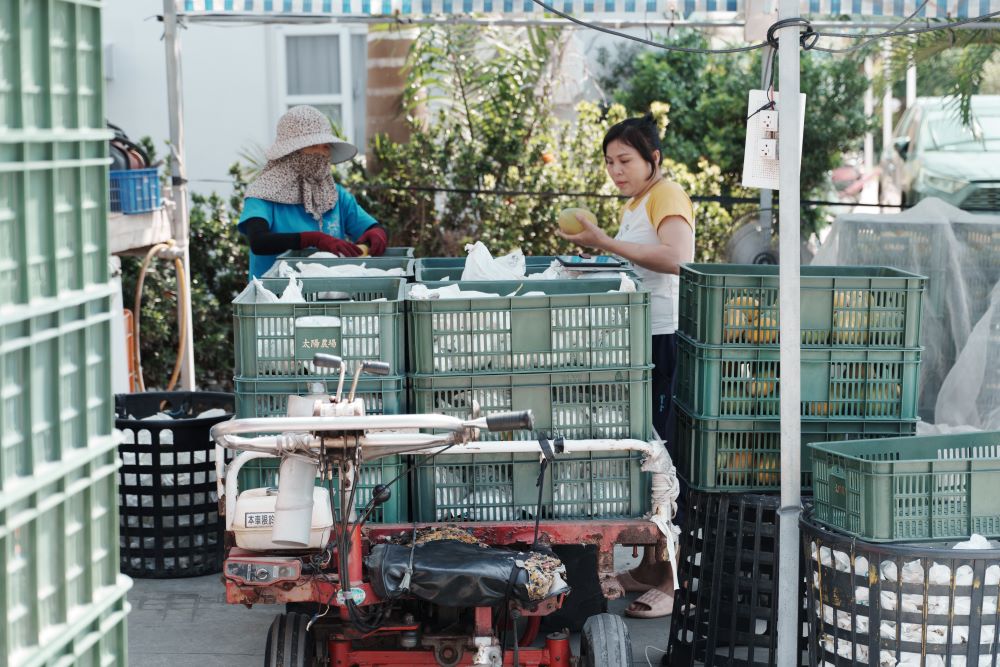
407, 274, 652, 521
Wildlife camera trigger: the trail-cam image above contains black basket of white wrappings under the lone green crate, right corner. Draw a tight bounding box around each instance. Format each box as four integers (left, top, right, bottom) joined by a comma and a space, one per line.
800, 515, 1000, 667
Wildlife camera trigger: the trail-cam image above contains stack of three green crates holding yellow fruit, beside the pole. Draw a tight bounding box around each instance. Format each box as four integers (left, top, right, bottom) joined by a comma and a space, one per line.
674, 264, 926, 491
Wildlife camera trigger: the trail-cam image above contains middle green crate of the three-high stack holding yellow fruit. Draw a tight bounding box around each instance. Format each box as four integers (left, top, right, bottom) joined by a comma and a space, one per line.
675, 334, 921, 420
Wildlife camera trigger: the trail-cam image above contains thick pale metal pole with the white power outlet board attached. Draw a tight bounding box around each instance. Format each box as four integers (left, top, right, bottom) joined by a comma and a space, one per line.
778, 0, 802, 667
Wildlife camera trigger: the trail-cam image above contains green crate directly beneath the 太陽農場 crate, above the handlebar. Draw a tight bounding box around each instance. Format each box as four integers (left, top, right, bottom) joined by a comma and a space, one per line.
234, 376, 406, 418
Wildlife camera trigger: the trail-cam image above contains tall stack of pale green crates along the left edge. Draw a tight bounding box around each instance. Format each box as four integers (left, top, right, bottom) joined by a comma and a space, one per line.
0, 0, 130, 667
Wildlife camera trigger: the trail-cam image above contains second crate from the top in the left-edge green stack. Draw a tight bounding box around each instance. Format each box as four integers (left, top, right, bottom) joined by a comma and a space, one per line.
0, 142, 110, 313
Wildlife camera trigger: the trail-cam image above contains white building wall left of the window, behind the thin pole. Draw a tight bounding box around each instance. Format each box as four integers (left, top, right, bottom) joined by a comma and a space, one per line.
103, 0, 277, 193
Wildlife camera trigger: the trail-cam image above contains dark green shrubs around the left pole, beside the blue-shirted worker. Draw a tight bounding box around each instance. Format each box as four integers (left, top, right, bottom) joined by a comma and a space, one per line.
122, 166, 249, 390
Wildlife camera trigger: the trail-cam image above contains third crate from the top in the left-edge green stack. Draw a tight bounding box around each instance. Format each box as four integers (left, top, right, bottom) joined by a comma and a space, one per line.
0, 286, 114, 491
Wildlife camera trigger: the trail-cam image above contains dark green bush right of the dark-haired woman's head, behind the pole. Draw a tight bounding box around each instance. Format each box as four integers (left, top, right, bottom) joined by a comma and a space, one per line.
601, 32, 868, 231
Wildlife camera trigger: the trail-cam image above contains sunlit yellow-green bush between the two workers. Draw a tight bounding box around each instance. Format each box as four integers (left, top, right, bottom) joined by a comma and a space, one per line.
340, 26, 729, 256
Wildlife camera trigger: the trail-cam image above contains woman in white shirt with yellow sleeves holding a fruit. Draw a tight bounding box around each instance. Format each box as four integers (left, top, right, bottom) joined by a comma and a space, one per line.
558, 114, 695, 618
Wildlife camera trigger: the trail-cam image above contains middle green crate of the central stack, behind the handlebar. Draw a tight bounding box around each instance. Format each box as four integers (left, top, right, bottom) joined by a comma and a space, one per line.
410, 367, 653, 440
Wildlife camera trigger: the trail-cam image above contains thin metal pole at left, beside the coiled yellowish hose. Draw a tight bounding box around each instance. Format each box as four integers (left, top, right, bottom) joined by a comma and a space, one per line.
163, 0, 195, 390
